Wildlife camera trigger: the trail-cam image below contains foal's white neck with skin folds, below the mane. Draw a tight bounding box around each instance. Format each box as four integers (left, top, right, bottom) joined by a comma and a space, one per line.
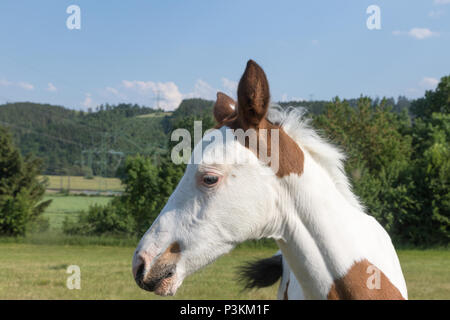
277, 153, 366, 299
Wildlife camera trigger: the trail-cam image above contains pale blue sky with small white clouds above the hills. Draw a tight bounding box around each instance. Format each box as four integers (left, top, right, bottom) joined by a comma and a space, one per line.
0, 0, 450, 111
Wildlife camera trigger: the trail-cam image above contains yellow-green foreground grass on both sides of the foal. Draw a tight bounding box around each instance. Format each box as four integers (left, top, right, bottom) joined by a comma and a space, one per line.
0, 243, 450, 299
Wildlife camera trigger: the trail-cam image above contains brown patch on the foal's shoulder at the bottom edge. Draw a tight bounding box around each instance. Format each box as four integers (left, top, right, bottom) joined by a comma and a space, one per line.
327, 259, 405, 300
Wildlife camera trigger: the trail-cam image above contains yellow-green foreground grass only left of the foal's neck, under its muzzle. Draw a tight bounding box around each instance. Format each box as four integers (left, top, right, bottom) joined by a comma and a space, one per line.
0, 244, 276, 299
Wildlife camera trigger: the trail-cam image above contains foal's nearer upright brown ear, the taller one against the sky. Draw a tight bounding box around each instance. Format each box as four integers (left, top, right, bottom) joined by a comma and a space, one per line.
238, 60, 270, 128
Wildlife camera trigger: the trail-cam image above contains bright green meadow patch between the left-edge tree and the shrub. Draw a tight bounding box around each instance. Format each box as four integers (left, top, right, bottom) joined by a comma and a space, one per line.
43, 195, 112, 231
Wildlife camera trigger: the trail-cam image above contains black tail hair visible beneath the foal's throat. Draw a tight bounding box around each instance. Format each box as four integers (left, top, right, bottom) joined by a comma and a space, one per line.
238, 254, 283, 290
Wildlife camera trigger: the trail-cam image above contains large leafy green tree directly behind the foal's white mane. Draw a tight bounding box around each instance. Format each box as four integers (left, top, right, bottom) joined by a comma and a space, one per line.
314, 97, 416, 236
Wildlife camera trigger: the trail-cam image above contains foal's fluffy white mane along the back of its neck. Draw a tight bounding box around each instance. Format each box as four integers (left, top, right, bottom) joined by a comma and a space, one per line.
267, 105, 365, 212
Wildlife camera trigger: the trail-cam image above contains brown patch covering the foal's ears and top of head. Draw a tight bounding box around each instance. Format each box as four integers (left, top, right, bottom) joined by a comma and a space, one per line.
214, 60, 304, 178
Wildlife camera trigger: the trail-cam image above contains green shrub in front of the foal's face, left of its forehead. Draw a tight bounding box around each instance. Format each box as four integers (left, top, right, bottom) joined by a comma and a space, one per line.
63, 155, 183, 235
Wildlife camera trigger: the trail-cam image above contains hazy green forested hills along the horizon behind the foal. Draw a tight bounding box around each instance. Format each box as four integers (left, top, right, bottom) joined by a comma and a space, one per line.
0, 98, 409, 176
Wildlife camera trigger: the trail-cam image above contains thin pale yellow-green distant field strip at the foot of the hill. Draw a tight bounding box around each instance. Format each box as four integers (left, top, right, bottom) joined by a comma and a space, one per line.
41, 176, 124, 191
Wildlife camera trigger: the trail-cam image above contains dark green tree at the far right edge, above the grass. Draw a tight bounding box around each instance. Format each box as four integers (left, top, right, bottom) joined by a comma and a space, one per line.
401, 113, 450, 245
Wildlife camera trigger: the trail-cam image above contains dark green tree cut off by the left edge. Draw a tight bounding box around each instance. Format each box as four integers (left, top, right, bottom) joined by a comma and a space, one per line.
0, 127, 51, 236
